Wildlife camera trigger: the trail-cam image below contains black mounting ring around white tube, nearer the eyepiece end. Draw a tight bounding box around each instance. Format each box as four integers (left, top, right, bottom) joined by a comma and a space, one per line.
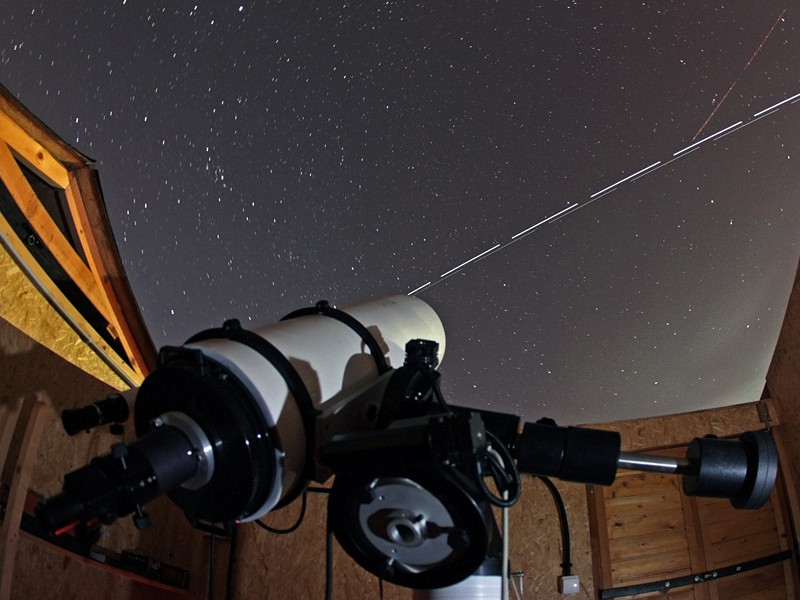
186, 319, 319, 508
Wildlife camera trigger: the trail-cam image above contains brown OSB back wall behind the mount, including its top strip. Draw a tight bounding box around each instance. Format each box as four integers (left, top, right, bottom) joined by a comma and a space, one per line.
227, 402, 792, 600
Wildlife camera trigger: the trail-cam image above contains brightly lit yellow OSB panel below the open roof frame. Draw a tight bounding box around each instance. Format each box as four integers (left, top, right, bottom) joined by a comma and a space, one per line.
0, 247, 129, 390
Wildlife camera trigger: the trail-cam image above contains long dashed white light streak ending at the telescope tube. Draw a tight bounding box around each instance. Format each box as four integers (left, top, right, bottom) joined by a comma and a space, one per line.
408, 91, 800, 296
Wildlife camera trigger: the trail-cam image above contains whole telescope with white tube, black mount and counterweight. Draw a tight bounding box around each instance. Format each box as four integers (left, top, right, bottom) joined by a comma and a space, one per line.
37, 295, 777, 598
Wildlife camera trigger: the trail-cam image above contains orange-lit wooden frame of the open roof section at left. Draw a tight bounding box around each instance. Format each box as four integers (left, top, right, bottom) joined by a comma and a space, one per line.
0, 85, 156, 383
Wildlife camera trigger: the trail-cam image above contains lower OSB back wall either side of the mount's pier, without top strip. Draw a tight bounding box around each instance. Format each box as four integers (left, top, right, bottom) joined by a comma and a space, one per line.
233, 476, 593, 600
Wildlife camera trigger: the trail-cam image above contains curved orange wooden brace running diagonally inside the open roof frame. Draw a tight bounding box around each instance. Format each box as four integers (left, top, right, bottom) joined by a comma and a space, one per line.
0, 142, 112, 323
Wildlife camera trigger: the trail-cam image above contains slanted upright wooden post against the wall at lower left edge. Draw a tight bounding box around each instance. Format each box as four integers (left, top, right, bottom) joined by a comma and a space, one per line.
0, 393, 47, 600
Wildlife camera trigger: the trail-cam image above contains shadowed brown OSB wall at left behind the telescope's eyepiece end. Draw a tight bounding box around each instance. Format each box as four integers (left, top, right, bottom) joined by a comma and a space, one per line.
0, 319, 205, 599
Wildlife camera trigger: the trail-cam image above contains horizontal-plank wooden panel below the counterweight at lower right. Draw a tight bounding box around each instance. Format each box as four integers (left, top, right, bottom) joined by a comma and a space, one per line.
590, 448, 795, 600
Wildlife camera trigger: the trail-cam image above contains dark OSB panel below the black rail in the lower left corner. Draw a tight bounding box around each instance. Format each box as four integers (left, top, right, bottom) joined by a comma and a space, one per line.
11, 537, 186, 600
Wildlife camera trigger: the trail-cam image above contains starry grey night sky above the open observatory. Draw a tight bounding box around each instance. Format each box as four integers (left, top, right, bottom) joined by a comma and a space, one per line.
0, 0, 800, 424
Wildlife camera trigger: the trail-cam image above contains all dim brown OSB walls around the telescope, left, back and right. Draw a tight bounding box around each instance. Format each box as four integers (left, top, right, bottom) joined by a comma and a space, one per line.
6, 264, 800, 600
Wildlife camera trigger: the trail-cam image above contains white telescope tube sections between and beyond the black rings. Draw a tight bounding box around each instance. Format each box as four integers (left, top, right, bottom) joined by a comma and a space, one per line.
186, 295, 445, 521
